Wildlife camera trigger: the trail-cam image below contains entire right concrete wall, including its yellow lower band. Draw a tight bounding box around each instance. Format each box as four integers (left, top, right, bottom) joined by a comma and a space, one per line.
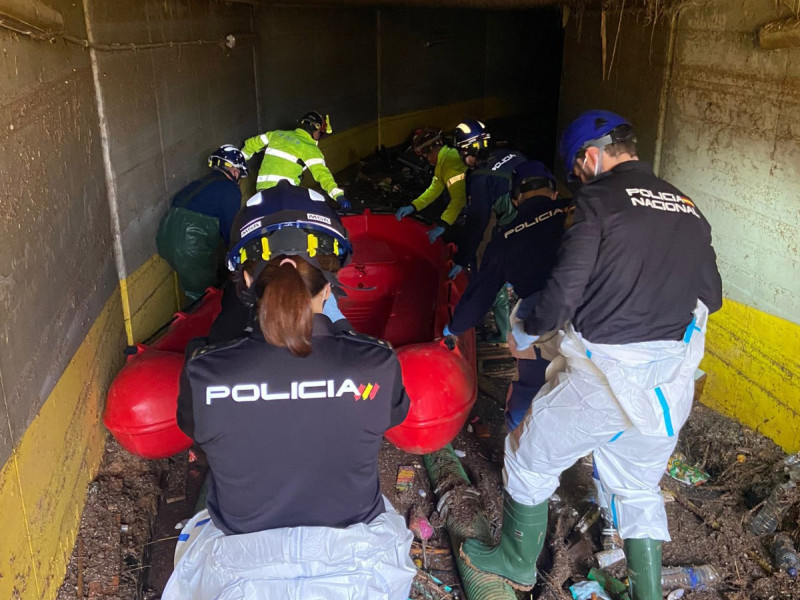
559, 0, 800, 451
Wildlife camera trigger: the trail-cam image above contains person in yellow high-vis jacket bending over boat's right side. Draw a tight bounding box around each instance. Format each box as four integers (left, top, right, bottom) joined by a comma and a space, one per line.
396, 129, 467, 244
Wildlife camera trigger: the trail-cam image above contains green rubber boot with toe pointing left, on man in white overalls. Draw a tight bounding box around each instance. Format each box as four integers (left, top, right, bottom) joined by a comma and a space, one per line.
461, 495, 547, 590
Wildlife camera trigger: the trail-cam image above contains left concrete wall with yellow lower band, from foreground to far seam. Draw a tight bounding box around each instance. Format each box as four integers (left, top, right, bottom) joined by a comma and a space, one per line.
0, 0, 257, 599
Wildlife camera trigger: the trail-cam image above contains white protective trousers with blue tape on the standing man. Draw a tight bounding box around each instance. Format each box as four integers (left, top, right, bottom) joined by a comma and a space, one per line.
503, 302, 708, 541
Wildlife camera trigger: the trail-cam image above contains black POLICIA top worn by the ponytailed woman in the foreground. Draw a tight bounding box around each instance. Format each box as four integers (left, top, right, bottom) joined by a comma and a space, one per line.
177, 315, 409, 534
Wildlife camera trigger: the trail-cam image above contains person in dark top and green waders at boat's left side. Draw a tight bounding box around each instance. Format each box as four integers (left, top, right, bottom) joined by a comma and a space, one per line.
156, 144, 247, 300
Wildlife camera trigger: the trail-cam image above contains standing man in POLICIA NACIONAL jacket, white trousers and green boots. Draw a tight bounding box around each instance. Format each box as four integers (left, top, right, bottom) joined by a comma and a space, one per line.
461, 110, 722, 600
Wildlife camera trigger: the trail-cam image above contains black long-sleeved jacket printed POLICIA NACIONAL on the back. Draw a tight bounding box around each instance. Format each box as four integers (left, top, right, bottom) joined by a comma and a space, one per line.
525, 160, 722, 344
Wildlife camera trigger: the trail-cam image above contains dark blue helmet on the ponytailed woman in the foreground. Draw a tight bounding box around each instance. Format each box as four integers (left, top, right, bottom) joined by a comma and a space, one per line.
227, 181, 353, 271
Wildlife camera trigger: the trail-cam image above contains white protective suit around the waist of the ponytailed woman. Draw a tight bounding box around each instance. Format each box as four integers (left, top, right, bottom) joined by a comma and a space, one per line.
161, 501, 417, 600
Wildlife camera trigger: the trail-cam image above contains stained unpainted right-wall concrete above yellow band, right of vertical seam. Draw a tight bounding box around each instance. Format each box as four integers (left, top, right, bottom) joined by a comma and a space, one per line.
663, 0, 800, 323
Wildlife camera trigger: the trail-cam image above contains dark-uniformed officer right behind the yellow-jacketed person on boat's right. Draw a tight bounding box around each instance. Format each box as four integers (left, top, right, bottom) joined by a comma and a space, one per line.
448, 119, 525, 344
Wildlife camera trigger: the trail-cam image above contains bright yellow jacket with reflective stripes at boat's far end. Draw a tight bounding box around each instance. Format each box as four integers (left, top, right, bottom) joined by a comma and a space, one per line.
242, 128, 344, 199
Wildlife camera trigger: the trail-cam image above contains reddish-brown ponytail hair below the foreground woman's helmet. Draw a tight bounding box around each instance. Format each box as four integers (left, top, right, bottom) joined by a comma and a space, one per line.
244, 254, 339, 356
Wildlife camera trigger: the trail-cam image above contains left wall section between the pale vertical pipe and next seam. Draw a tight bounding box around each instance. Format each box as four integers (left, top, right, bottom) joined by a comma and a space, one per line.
87, 0, 257, 341
